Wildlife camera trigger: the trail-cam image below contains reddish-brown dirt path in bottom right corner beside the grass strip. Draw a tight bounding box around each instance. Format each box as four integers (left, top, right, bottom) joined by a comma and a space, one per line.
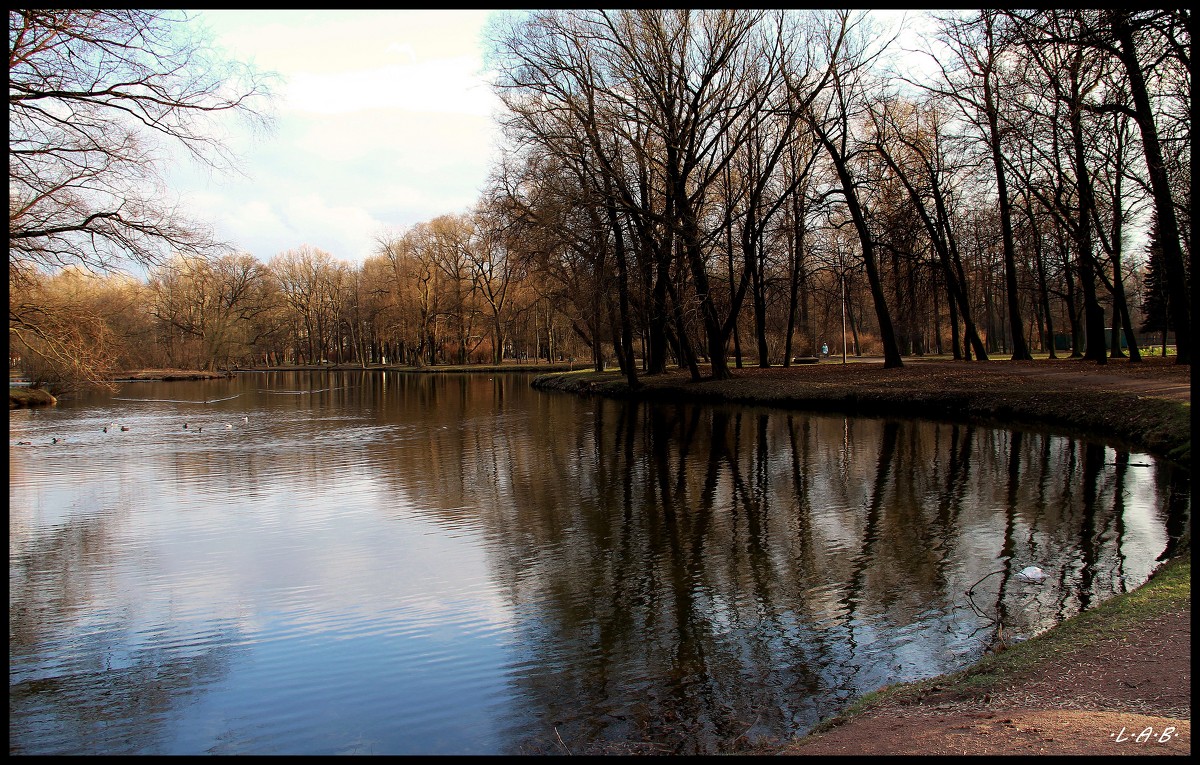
779, 608, 1192, 754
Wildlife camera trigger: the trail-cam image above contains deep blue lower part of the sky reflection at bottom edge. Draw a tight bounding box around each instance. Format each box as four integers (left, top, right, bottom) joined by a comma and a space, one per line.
167, 598, 508, 754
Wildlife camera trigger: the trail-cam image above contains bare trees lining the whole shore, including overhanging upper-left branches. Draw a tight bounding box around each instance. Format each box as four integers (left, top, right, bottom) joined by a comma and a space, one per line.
10, 8, 1192, 393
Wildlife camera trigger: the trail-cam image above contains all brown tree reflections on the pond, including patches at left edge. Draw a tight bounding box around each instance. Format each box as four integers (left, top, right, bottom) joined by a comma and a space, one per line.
10, 373, 1190, 753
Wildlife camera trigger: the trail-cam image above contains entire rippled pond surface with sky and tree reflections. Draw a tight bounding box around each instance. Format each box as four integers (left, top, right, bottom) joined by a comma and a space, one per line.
8, 373, 1190, 754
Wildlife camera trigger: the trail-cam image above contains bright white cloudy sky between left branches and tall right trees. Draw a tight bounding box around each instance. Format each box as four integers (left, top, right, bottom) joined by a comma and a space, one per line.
167, 10, 499, 263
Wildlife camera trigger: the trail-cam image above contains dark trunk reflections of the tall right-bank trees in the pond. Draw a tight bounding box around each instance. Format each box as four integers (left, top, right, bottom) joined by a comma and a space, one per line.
381, 386, 1180, 753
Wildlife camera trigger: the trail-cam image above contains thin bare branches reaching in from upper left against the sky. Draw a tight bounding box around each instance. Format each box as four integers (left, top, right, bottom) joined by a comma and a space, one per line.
8, 8, 269, 379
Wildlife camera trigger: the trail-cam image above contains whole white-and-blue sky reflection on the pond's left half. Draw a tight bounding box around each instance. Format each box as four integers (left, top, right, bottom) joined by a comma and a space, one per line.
10, 402, 523, 754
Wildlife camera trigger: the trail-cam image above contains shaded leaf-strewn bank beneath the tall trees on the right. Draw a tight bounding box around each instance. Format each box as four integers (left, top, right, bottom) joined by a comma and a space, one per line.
530, 360, 1192, 468
